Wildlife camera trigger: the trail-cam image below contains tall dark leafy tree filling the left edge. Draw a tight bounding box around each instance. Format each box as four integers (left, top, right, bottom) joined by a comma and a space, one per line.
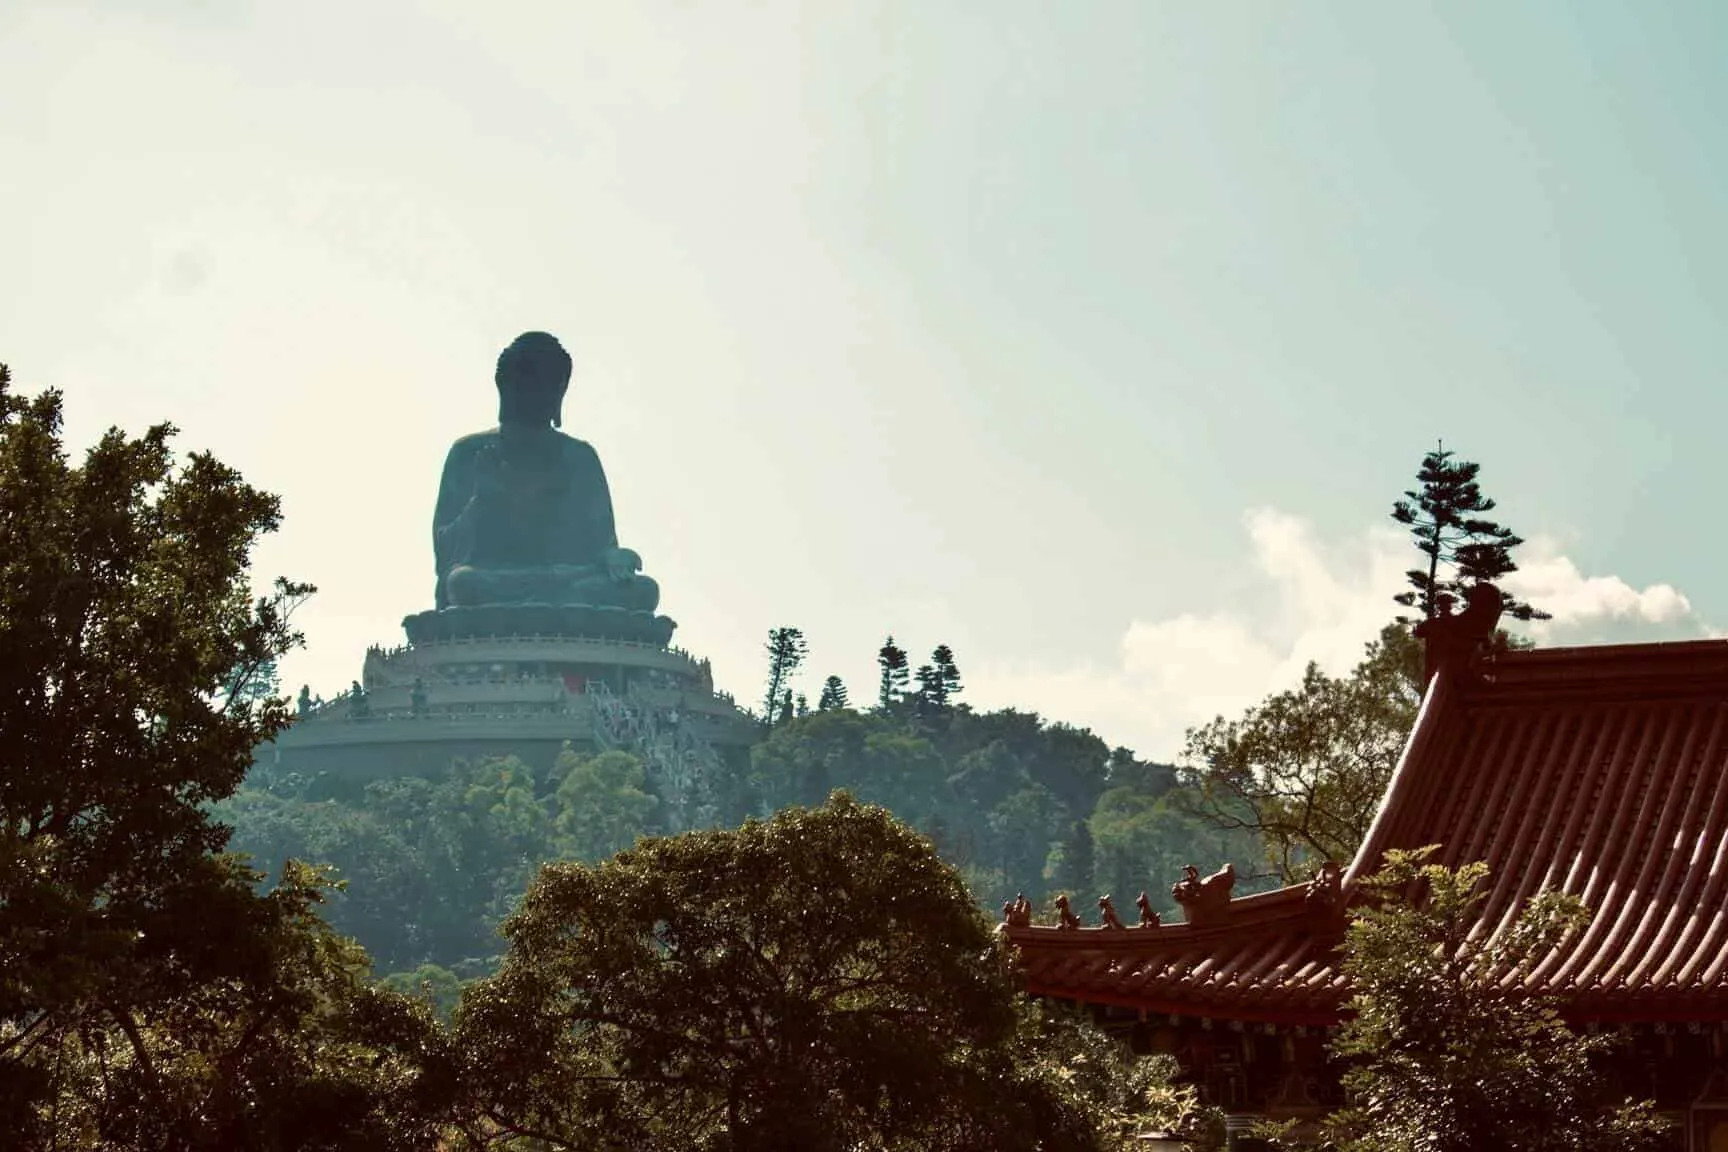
0, 368, 445, 1149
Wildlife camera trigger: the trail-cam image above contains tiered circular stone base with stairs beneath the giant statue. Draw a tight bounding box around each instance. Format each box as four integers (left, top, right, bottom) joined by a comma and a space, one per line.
256, 604, 760, 826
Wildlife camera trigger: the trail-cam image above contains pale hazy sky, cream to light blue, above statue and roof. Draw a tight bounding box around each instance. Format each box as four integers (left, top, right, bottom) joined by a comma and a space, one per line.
0, 0, 1728, 760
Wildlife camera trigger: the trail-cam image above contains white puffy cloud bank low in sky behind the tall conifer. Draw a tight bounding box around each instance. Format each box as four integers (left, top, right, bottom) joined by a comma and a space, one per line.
968, 508, 1721, 760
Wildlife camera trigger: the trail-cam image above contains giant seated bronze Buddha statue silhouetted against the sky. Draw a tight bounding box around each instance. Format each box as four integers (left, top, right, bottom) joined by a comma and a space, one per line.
432, 332, 660, 613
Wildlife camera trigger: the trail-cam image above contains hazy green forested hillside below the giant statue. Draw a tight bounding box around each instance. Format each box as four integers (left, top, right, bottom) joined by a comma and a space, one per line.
218, 694, 1265, 986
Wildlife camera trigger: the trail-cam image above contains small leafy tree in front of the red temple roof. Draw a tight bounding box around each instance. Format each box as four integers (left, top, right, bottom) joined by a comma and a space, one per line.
1278, 848, 1662, 1152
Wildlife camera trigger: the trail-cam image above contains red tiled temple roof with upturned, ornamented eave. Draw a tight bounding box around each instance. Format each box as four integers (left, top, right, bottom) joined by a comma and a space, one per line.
1004, 641, 1728, 1024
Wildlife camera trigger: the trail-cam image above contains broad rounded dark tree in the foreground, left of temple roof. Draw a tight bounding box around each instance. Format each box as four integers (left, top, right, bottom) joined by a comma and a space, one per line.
456, 794, 1099, 1152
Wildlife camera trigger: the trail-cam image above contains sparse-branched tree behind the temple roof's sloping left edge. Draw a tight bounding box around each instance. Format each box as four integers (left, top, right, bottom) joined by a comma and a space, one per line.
1181, 623, 1422, 884
